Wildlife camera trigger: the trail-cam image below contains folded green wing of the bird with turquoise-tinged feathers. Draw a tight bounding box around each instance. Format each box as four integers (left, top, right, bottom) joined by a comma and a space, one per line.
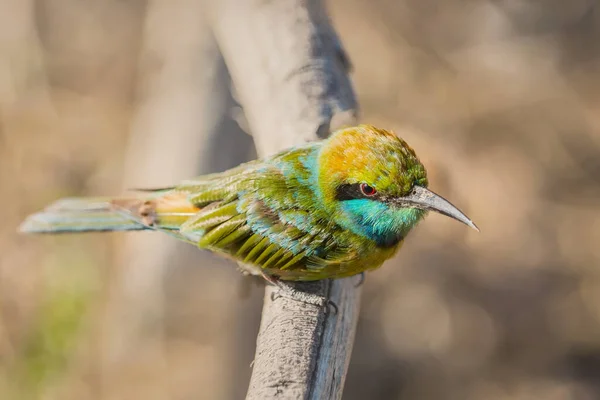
177, 149, 355, 274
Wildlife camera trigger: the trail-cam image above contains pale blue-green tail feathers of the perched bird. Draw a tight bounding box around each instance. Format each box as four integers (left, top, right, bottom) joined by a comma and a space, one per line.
19, 197, 148, 233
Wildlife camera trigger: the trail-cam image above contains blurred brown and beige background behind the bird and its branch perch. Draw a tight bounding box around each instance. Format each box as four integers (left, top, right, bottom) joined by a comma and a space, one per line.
0, 0, 600, 400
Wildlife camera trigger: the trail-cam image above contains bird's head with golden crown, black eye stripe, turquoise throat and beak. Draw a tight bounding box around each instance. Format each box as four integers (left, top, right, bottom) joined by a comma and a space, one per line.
318, 125, 477, 247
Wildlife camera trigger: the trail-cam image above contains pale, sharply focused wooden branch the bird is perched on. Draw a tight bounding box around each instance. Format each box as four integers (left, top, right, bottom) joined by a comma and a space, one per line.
210, 0, 360, 400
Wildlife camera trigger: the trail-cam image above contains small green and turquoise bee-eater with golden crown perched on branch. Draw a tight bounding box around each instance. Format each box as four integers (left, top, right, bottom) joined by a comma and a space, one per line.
19, 124, 479, 283
